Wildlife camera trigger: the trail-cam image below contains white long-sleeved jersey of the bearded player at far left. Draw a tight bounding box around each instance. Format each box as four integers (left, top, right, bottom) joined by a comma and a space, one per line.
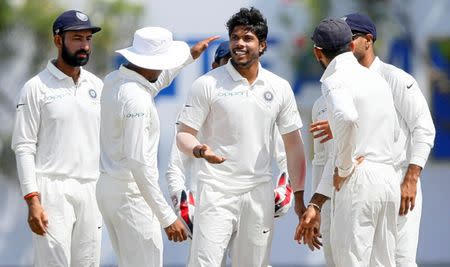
11, 61, 103, 195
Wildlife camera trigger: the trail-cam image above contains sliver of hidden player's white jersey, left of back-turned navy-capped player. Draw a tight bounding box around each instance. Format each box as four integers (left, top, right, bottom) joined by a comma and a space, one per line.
311, 96, 334, 197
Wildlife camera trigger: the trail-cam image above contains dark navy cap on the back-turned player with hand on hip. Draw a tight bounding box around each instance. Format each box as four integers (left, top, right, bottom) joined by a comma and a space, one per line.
311, 19, 352, 50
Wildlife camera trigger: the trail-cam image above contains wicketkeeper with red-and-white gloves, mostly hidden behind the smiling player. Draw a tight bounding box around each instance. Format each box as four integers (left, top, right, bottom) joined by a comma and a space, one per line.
166, 41, 293, 241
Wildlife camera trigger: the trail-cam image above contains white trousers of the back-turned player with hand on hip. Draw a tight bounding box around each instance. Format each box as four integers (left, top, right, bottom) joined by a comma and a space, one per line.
331, 160, 400, 267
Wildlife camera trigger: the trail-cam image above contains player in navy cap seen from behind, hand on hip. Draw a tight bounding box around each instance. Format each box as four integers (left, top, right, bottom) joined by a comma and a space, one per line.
295, 19, 400, 266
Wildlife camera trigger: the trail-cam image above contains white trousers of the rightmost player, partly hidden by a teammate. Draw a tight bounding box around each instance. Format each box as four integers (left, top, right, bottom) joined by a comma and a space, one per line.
395, 169, 422, 267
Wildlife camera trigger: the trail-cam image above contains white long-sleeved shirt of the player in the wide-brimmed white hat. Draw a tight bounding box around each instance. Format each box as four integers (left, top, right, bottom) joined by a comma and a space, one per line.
100, 57, 193, 228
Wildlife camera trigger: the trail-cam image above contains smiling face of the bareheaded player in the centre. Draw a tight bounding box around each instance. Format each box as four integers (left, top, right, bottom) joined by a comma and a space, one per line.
230, 26, 266, 68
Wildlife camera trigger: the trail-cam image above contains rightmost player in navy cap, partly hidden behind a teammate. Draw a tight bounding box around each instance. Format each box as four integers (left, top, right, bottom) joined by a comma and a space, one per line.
343, 13, 436, 267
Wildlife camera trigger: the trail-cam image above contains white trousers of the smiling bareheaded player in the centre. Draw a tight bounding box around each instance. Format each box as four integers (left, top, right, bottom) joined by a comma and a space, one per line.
188, 181, 274, 267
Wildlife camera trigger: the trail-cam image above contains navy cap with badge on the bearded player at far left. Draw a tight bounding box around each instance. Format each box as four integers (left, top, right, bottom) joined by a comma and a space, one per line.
53, 10, 101, 35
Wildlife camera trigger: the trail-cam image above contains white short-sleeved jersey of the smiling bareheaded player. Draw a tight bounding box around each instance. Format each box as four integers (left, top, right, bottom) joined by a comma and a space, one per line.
179, 61, 302, 193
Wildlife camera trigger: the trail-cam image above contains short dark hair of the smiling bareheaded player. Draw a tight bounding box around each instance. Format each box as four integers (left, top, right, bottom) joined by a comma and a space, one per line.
227, 7, 269, 52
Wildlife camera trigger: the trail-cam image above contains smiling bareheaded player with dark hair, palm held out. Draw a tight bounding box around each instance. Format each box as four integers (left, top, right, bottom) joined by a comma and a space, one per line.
177, 8, 306, 267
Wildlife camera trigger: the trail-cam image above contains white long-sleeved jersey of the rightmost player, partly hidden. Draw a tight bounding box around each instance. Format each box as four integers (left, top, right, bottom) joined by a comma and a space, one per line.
369, 57, 436, 168
